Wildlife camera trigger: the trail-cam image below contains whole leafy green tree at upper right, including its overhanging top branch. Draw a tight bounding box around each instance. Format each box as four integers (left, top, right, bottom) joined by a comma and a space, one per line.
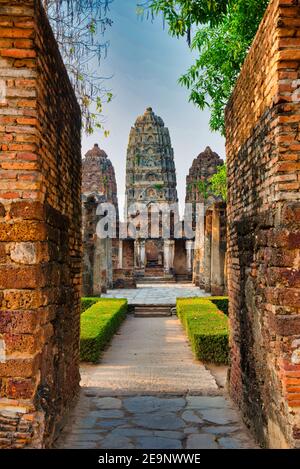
143, 0, 269, 134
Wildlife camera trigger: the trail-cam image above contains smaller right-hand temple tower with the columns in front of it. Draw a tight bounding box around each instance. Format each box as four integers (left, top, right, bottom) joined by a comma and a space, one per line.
185, 147, 227, 295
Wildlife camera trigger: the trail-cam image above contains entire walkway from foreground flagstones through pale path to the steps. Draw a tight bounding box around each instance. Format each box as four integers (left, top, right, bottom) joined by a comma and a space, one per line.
56, 317, 255, 449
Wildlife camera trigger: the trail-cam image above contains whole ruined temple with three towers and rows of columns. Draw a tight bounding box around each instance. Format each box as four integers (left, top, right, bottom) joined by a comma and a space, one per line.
82, 108, 226, 288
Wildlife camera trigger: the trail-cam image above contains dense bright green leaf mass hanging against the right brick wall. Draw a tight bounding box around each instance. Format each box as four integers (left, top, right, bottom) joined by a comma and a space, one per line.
179, 0, 268, 134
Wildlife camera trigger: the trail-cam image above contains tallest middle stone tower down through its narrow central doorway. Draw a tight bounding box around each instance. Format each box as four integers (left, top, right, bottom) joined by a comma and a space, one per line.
124, 107, 178, 278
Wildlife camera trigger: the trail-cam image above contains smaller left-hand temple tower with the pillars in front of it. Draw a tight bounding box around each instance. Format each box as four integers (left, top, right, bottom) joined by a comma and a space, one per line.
82, 144, 119, 296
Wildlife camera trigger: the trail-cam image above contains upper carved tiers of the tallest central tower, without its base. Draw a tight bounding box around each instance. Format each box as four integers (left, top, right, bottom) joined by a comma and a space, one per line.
126, 107, 178, 211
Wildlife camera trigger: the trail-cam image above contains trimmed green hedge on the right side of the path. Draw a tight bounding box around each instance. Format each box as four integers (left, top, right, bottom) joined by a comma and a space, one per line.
177, 297, 229, 365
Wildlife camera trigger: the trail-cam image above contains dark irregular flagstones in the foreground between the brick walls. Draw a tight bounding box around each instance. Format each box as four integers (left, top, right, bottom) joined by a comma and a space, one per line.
56, 390, 255, 449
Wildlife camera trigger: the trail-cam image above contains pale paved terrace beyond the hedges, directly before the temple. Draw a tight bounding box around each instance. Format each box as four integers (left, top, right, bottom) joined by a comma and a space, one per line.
102, 283, 210, 305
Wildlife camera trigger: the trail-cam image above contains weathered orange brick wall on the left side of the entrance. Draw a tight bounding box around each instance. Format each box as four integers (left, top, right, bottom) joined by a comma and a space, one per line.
0, 0, 81, 447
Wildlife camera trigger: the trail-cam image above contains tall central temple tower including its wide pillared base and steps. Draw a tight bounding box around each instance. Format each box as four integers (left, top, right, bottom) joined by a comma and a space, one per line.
119, 107, 191, 281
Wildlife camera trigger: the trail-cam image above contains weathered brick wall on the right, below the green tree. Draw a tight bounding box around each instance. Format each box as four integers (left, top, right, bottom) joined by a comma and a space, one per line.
226, 0, 300, 447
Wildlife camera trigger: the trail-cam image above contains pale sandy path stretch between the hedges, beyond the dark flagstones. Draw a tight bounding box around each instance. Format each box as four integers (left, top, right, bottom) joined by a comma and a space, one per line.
81, 316, 218, 396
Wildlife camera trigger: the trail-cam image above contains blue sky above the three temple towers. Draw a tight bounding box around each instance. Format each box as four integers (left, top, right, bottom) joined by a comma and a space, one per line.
82, 0, 225, 218
